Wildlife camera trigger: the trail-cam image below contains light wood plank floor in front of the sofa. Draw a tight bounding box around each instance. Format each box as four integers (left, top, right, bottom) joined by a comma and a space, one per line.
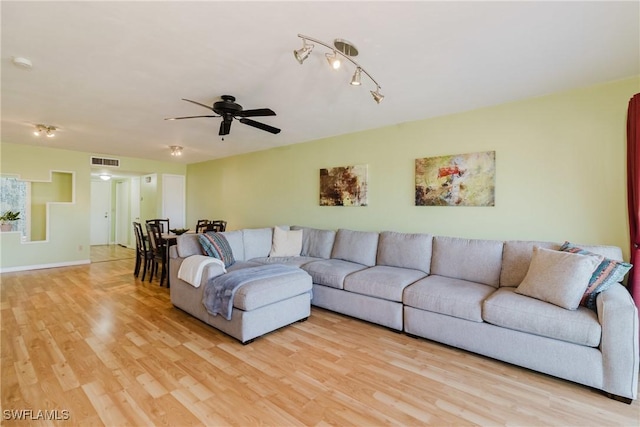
0, 259, 640, 426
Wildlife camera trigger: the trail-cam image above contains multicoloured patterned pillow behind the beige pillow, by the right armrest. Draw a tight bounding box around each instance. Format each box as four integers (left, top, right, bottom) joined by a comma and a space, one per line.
560, 242, 633, 310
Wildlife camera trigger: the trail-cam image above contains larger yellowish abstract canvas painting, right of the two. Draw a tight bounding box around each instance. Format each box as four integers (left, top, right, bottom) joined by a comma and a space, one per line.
415, 151, 496, 206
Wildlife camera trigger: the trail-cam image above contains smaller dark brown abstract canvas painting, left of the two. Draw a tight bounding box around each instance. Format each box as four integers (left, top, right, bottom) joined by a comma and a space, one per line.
320, 165, 367, 206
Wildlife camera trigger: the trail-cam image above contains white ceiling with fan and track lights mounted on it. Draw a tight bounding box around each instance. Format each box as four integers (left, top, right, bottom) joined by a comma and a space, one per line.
0, 0, 640, 163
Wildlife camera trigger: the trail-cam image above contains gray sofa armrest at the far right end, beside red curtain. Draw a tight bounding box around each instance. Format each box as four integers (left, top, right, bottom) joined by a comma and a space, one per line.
596, 283, 639, 399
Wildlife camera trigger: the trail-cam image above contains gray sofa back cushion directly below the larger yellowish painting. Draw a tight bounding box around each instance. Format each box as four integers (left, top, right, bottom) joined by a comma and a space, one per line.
431, 236, 503, 288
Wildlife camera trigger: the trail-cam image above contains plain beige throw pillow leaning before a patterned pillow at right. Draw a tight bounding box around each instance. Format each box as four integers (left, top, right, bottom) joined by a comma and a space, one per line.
516, 246, 602, 310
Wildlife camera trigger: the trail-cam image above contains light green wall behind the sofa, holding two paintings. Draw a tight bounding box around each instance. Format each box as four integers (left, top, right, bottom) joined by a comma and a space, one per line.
187, 77, 640, 256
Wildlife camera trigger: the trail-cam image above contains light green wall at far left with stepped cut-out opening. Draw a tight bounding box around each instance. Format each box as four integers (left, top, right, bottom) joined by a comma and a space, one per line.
0, 143, 186, 271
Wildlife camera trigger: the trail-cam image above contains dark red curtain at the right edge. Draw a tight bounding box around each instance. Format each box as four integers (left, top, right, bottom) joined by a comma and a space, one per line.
627, 93, 640, 308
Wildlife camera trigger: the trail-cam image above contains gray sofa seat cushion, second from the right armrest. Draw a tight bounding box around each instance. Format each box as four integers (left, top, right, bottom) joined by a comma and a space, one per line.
402, 275, 496, 322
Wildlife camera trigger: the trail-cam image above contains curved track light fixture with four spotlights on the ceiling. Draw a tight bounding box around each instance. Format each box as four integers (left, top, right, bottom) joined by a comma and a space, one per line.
293, 34, 384, 104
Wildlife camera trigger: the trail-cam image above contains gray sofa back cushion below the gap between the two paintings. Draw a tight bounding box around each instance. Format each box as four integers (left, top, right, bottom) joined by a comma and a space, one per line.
376, 231, 433, 274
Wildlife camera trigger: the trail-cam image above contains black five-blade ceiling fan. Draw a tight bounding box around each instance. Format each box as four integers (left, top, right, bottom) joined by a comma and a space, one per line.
165, 95, 280, 136
